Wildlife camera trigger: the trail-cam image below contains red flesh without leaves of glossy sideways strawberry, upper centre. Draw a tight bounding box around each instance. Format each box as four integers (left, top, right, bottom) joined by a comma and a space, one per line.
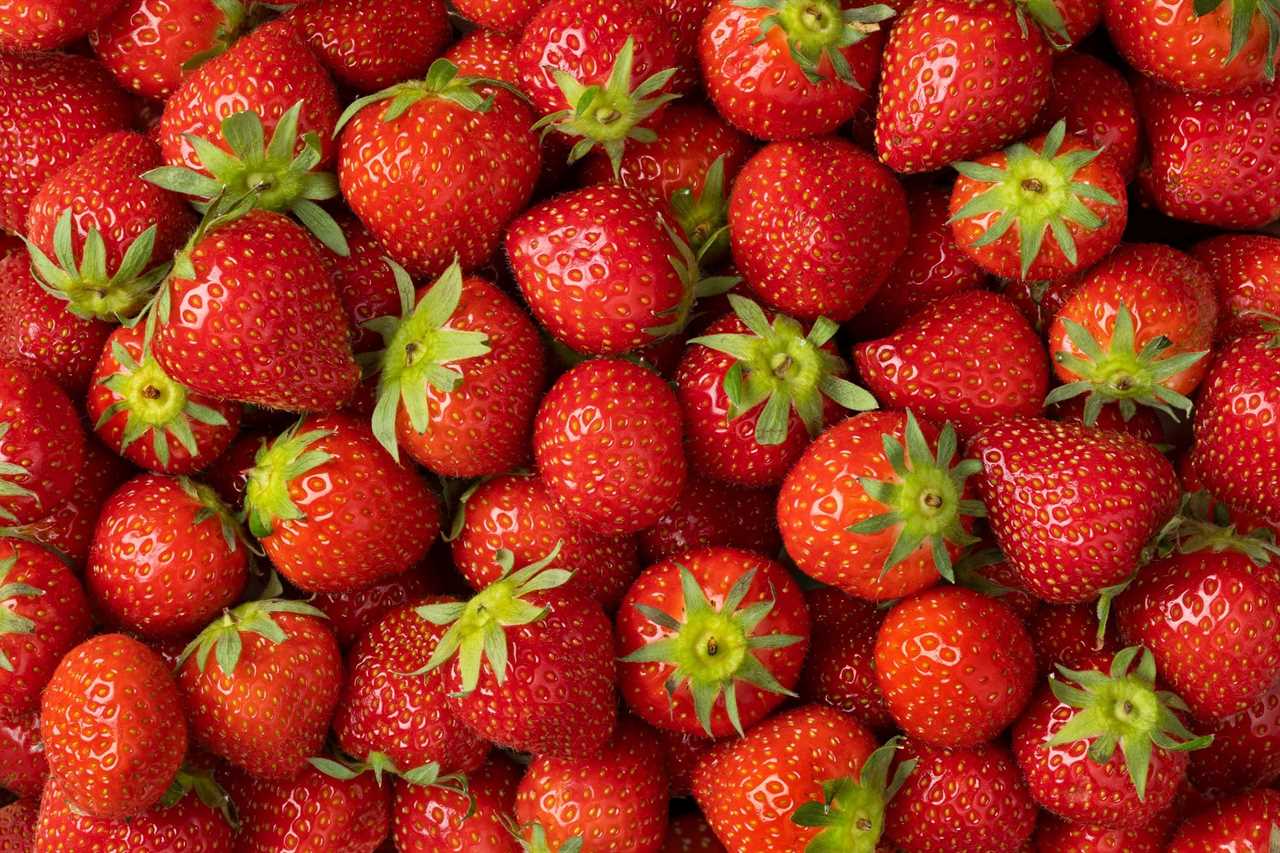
507, 184, 685, 355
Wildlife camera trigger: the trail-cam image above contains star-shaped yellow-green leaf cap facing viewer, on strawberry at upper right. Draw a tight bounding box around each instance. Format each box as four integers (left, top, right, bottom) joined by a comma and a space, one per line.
951, 122, 1120, 278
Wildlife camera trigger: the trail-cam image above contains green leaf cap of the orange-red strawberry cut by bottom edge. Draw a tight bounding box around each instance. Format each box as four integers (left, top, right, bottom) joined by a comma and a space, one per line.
791, 738, 916, 853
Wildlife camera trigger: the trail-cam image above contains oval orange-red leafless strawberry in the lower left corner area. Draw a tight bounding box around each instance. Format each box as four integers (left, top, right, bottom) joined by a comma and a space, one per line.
40, 634, 187, 818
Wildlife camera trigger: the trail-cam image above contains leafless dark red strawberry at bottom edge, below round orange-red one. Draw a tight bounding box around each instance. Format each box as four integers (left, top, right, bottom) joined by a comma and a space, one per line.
884, 739, 1038, 853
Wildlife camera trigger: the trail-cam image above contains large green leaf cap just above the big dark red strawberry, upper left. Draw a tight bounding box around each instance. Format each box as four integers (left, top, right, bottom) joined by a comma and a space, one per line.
142, 101, 351, 257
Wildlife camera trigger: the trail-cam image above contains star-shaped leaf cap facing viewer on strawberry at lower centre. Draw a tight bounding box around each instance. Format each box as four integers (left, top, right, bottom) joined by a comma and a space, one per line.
621, 562, 801, 736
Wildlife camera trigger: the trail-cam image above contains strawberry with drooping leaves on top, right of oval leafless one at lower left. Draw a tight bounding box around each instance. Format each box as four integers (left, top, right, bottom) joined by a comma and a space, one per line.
177, 575, 342, 781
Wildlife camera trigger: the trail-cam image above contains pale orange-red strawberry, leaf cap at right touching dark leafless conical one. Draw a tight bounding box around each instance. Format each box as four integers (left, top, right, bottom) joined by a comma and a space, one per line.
778, 411, 983, 601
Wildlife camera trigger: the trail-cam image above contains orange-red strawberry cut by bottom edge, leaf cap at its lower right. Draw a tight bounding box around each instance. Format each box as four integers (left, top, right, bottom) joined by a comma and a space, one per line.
694, 704, 913, 852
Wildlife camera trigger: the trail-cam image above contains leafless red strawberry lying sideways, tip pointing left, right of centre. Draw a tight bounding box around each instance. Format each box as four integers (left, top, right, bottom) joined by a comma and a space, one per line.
854, 291, 1048, 438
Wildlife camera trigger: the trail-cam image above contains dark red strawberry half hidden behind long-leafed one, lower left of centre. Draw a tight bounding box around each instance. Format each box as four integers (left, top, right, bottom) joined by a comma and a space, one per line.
333, 598, 489, 774
